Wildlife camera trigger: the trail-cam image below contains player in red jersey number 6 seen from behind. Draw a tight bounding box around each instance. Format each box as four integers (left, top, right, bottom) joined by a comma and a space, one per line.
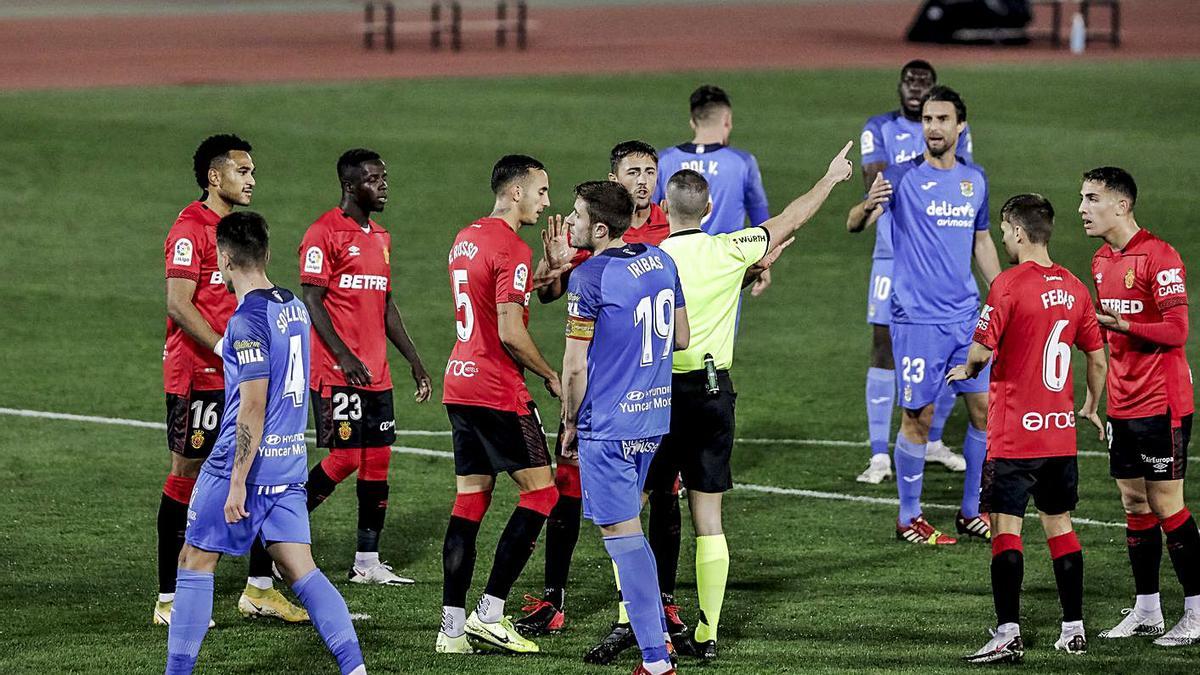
946, 195, 1106, 663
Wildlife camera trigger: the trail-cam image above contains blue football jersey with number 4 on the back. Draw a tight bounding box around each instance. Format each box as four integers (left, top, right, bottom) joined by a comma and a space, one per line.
204, 286, 311, 485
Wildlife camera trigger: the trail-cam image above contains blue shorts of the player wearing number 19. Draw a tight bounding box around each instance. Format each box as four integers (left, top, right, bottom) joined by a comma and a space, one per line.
580, 436, 662, 526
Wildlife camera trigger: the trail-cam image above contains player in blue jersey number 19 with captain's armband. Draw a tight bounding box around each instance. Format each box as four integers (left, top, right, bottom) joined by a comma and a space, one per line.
563, 181, 689, 675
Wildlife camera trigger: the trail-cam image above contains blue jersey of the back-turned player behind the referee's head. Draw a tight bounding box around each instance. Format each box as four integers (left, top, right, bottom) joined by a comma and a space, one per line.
653, 143, 770, 234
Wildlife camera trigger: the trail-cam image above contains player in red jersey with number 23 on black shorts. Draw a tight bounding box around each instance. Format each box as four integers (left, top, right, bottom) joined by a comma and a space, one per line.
300, 148, 432, 586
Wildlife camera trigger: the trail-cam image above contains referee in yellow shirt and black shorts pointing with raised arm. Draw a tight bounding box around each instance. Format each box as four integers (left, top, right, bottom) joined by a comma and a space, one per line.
646, 143, 853, 659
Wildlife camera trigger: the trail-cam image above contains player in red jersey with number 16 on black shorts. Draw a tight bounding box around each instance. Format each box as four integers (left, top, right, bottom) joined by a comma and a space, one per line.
152, 133, 308, 626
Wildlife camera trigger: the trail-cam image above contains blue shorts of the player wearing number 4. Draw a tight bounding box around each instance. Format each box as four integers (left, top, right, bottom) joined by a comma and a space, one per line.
185, 471, 312, 556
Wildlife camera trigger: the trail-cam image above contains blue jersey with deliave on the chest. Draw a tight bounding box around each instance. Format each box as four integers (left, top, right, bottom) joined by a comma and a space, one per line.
883, 157, 989, 324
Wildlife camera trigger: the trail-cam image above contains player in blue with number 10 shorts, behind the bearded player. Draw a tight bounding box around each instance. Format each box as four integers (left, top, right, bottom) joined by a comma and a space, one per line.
846, 60, 972, 484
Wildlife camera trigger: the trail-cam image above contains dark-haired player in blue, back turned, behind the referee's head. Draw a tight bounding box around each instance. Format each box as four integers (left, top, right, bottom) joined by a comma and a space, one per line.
652, 84, 770, 295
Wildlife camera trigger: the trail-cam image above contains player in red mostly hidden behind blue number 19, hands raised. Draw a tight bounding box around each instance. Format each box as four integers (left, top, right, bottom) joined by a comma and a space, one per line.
516, 141, 686, 646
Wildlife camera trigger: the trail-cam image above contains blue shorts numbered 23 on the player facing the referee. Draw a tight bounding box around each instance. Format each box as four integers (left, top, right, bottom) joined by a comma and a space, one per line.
889, 318, 991, 410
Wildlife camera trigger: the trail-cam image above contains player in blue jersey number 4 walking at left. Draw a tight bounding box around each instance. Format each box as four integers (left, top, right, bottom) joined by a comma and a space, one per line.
167, 211, 366, 675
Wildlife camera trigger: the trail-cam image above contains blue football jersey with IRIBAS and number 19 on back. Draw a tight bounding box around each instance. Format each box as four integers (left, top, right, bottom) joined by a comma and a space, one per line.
566, 244, 684, 441
